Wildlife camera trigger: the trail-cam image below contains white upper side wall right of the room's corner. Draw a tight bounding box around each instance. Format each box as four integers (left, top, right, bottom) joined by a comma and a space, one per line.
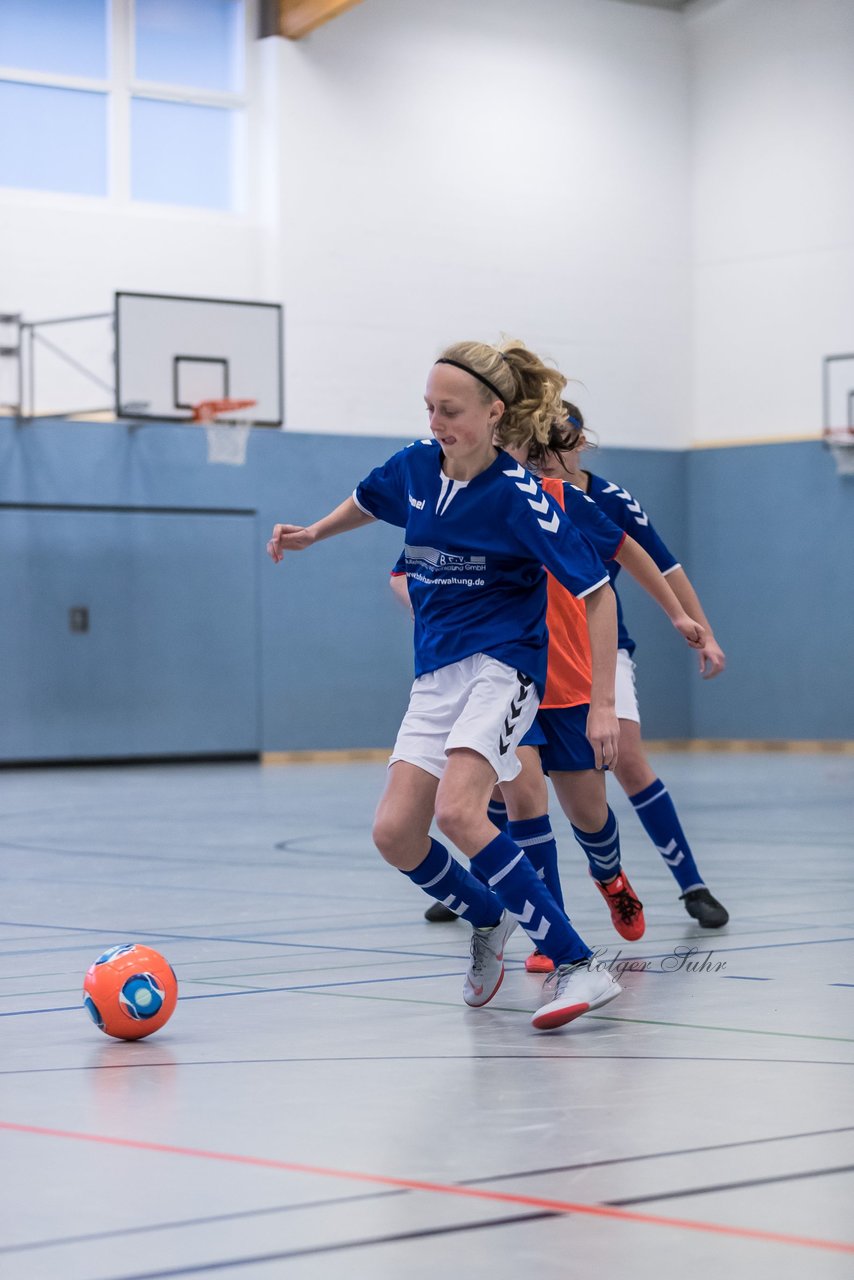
688, 0, 854, 440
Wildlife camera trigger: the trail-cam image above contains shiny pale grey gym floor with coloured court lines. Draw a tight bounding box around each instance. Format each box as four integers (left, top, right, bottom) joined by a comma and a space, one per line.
0, 755, 854, 1280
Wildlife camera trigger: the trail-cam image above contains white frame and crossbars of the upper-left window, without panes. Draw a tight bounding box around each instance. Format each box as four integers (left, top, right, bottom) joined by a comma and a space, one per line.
0, 0, 257, 221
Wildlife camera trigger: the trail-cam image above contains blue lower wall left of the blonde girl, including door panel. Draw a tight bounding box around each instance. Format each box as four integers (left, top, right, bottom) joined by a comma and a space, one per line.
0, 421, 411, 760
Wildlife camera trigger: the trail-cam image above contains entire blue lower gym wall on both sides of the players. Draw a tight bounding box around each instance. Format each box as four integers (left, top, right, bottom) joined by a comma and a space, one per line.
0, 421, 854, 760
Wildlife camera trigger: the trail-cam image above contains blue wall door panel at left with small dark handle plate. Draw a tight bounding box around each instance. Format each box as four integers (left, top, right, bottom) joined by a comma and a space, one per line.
0, 507, 259, 760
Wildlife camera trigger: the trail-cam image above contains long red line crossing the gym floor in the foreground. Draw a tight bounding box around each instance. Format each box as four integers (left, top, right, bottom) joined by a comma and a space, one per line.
0, 1120, 854, 1253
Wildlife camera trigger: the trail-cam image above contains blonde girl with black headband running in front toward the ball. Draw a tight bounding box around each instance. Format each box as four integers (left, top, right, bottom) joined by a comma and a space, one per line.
268, 343, 702, 1029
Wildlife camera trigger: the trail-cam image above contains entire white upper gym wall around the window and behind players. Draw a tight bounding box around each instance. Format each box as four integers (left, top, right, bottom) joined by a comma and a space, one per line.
0, 0, 854, 448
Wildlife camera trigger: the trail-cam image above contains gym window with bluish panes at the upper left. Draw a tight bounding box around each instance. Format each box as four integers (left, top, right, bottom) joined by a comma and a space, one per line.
0, 0, 251, 211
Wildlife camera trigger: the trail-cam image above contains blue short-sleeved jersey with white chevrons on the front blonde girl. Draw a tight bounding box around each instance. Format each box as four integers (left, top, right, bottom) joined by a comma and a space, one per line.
353, 440, 608, 696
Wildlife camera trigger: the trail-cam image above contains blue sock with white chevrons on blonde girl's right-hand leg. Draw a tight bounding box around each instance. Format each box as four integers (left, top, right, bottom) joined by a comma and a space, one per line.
474, 832, 590, 965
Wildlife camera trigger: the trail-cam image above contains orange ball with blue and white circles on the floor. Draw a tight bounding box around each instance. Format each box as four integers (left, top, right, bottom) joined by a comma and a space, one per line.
83, 942, 178, 1039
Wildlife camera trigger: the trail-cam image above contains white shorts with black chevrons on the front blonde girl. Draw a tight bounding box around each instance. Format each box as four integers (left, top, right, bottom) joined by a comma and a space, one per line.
388, 653, 539, 782
